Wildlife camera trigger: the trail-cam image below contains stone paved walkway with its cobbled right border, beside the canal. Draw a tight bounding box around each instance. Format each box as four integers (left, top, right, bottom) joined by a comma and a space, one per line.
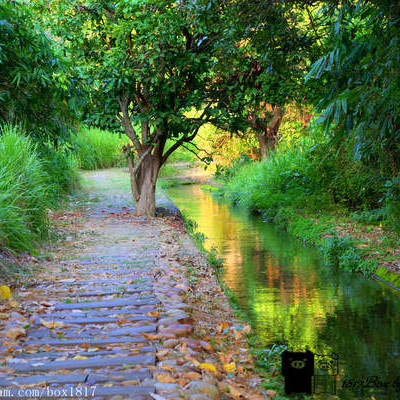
0, 172, 268, 400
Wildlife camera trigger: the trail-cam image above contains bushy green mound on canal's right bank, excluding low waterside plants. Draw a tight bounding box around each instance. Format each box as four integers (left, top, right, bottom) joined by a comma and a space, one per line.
224, 128, 384, 219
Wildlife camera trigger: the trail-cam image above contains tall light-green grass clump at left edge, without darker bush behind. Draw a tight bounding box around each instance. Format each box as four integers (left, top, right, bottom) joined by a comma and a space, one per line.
0, 126, 55, 251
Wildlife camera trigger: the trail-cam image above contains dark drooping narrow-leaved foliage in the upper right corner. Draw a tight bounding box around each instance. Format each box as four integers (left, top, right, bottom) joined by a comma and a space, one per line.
307, 0, 400, 177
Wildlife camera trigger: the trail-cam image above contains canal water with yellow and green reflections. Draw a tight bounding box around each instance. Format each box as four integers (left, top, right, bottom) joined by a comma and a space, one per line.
167, 185, 400, 400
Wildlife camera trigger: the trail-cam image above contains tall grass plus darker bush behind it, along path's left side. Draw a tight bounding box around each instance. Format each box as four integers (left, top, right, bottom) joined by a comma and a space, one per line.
0, 125, 78, 269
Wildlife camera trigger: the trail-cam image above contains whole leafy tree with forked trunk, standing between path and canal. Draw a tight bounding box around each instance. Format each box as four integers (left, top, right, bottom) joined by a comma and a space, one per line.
47, 0, 266, 215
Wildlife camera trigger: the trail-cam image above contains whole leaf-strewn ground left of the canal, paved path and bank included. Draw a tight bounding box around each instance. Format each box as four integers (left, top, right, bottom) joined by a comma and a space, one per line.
0, 169, 275, 400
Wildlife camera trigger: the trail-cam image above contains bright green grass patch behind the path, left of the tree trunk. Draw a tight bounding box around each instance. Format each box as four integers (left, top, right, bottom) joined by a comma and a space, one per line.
71, 127, 127, 170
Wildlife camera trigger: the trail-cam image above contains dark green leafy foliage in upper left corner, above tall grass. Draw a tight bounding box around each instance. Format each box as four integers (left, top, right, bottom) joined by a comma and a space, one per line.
0, 0, 79, 143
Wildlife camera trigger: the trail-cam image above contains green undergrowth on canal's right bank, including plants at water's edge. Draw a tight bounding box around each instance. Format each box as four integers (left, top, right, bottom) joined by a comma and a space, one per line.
219, 135, 388, 275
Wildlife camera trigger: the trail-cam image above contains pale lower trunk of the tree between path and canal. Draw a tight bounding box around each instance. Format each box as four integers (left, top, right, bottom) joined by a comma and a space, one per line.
128, 154, 161, 217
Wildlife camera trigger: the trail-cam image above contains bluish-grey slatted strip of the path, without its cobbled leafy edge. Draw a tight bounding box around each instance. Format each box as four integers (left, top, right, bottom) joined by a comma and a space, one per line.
0, 174, 196, 400
